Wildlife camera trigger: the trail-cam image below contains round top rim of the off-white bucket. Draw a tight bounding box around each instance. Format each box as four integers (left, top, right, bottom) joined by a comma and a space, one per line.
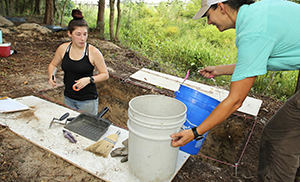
128, 94, 187, 119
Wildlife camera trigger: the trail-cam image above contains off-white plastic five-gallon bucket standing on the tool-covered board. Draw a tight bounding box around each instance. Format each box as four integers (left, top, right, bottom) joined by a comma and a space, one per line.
127, 95, 187, 182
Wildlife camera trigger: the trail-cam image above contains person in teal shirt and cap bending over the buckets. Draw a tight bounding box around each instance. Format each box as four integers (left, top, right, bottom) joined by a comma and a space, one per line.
171, 0, 300, 182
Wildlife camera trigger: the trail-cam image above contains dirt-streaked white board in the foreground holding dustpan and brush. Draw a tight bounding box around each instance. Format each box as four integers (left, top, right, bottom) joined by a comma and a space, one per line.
0, 96, 190, 182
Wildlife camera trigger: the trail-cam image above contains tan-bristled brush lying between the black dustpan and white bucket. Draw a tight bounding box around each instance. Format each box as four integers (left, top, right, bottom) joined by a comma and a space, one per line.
86, 131, 121, 157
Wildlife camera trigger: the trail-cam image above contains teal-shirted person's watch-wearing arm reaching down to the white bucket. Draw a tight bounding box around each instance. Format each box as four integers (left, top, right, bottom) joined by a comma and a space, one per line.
171, 77, 256, 147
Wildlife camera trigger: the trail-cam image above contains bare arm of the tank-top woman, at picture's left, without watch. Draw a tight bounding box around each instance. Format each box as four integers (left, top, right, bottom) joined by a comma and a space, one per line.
48, 44, 66, 87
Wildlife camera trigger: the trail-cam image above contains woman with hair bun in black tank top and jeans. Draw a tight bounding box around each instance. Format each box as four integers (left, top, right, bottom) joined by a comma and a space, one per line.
48, 9, 109, 115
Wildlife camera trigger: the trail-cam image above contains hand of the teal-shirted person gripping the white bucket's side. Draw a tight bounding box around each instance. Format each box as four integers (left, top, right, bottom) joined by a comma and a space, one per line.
170, 130, 194, 147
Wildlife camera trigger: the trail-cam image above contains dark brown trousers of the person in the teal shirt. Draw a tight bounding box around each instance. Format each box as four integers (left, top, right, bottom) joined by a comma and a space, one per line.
258, 91, 300, 182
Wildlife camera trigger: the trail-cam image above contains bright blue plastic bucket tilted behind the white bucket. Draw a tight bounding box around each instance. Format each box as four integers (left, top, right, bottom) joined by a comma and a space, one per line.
175, 85, 220, 155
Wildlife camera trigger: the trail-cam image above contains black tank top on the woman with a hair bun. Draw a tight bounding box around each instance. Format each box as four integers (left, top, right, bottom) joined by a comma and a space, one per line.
61, 43, 98, 101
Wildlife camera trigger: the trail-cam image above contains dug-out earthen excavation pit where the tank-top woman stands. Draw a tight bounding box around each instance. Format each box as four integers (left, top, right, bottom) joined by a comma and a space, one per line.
38, 77, 254, 168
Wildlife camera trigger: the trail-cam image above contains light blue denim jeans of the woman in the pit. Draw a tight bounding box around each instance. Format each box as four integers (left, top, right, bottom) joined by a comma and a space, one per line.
64, 96, 98, 115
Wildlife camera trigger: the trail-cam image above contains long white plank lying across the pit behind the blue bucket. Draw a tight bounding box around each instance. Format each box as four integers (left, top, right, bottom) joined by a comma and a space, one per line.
130, 68, 262, 116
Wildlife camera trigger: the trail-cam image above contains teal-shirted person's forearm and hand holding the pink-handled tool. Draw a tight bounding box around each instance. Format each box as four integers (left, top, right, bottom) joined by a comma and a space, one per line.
199, 64, 235, 78
